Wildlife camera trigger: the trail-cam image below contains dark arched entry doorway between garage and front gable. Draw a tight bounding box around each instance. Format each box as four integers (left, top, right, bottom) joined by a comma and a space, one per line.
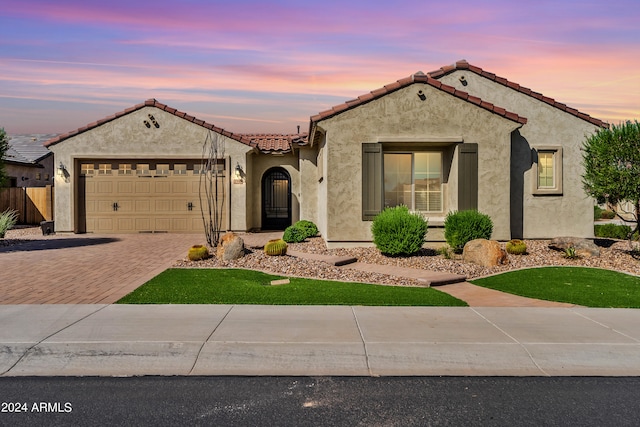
262, 167, 291, 230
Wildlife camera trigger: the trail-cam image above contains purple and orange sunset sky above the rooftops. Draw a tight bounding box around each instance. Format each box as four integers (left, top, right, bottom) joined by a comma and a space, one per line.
0, 0, 640, 134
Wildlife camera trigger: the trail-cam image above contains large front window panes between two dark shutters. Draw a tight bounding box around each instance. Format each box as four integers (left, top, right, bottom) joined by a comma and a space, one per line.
384, 152, 442, 212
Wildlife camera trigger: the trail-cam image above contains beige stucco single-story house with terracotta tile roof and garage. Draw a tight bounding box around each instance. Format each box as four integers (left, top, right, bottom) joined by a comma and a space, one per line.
46, 61, 607, 247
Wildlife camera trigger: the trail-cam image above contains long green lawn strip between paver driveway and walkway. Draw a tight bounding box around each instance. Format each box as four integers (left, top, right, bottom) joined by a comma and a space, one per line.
118, 268, 467, 306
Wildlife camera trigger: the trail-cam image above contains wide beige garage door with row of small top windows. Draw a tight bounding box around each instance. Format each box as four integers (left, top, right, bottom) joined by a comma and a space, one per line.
79, 160, 226, 233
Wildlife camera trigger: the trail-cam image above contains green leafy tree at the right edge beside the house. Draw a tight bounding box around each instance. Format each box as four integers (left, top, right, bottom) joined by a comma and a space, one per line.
582, 121, 640, 238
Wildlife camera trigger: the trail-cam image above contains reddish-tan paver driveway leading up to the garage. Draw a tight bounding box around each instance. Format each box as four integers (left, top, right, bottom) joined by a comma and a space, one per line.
0, 234, 204, 304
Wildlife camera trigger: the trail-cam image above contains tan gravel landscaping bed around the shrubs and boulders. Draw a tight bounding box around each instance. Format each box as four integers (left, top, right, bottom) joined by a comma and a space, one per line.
5, 227, 640, 286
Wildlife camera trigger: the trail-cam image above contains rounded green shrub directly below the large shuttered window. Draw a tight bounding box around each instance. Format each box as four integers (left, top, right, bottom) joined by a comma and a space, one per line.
371, 206, 428, 255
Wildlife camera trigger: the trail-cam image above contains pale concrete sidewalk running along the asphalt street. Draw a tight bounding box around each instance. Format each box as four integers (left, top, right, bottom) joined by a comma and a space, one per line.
0, 305, 640, 376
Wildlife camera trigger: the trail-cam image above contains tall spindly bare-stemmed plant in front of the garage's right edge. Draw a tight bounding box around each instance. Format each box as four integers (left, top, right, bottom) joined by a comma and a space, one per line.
199, 132, 225, 248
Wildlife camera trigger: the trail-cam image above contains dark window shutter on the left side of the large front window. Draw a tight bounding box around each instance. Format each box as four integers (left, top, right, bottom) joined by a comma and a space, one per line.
362, 143, 383, 221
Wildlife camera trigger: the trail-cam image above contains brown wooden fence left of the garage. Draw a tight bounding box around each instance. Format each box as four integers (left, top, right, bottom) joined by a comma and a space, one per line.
0, 185, 53, 225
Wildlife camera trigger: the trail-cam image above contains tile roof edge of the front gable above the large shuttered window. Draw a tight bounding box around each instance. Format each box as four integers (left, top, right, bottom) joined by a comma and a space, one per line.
311, 71, 527, 127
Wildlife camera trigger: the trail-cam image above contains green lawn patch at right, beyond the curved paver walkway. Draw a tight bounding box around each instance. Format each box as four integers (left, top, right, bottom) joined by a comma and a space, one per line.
471, 267, 640, 308
